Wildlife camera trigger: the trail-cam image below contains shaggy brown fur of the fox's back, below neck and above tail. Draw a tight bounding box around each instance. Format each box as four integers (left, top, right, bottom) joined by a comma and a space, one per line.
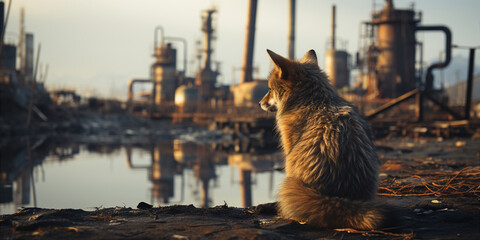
278, 102, 378, 200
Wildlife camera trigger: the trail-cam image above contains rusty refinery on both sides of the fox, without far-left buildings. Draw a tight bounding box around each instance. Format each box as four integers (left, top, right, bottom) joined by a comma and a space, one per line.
124, 0, 480, 137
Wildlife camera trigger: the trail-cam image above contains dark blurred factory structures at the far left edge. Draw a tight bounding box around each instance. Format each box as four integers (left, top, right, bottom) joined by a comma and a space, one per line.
0, 2, 52, 127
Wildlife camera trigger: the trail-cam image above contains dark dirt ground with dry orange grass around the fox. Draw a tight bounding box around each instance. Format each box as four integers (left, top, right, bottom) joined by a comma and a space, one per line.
0, 138, 480, 239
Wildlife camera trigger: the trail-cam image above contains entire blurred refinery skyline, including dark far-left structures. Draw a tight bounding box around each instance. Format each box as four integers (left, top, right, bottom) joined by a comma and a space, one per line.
0, 0, 478, 138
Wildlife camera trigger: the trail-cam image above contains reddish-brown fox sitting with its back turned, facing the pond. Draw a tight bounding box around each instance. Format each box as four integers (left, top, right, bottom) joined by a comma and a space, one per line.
259, 49, 388, 230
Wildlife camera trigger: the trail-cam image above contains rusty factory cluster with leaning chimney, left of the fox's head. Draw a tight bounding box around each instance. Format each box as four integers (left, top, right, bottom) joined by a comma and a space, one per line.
127, 1, 268, 124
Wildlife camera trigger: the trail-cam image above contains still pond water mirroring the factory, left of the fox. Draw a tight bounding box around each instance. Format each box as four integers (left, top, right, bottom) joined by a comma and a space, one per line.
0, 135, 283, 214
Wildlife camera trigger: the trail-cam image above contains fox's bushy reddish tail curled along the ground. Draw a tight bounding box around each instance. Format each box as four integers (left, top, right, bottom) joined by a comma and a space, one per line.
278, 177, 387, 230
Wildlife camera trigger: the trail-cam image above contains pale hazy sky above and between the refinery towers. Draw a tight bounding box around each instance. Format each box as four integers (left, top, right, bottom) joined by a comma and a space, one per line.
5, 0, 480, 99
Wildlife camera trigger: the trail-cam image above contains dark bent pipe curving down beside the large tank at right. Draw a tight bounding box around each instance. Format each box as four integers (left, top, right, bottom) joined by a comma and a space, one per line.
415, 26, 452, 92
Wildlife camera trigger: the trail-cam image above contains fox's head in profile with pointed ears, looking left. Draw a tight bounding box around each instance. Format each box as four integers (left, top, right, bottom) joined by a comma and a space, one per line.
259, 49, 318, 112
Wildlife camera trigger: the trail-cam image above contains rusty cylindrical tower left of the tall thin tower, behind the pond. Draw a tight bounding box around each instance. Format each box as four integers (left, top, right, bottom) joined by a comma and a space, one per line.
152, 43, 177, 104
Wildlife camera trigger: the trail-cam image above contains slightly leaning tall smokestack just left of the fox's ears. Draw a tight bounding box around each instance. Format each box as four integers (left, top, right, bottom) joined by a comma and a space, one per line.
241, 0, 257, 83
